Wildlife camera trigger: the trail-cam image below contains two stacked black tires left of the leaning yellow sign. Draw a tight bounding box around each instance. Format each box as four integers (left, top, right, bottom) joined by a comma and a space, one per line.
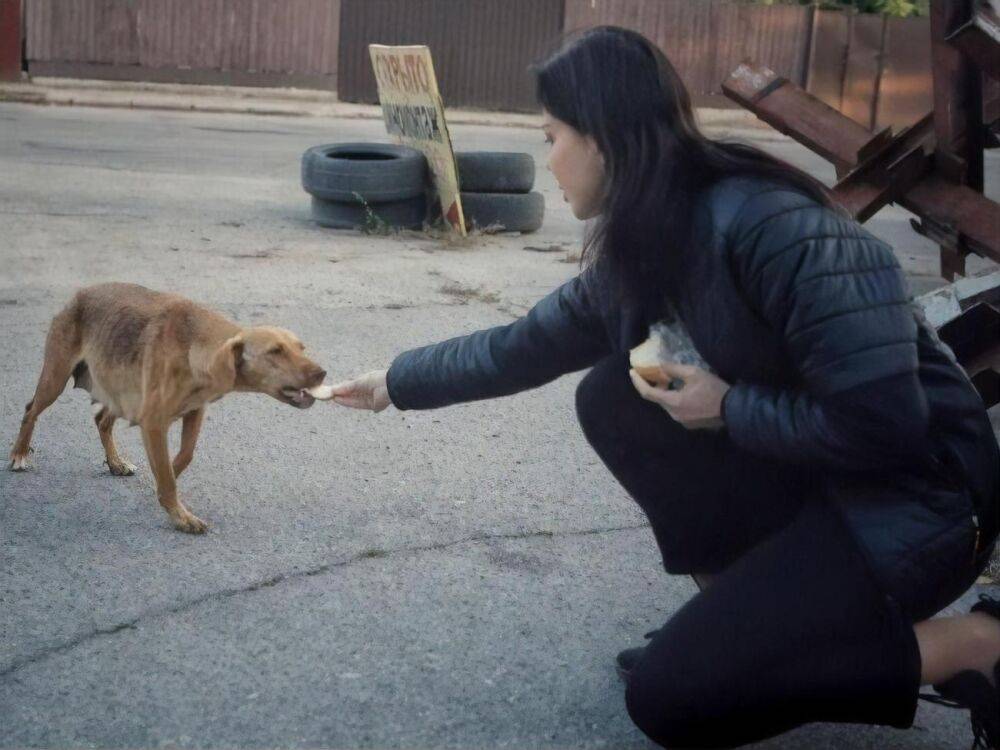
302, 143, 427, 230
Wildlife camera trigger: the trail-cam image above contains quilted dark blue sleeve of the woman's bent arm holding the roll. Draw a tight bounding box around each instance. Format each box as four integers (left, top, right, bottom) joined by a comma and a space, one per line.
723, 191, 929, 470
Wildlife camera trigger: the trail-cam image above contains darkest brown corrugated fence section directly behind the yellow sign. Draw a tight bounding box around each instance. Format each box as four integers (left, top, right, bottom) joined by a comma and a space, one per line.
338, 0, 563, 111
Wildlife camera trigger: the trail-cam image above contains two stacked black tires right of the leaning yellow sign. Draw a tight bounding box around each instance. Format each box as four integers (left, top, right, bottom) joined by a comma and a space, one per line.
455, 151, 545, 232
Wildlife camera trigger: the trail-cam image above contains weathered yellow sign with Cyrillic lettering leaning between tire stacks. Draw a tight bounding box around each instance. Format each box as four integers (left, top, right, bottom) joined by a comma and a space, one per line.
368, 44, 465, 237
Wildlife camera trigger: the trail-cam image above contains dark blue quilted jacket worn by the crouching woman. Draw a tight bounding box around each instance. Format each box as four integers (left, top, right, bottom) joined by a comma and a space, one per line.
388, 177, 1000, 600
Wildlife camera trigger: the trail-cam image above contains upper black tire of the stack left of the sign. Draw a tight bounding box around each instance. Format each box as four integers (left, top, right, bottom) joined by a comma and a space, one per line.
302, 143, 427, 203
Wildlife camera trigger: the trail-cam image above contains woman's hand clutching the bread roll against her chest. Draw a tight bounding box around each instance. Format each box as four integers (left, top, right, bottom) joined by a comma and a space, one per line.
629, 362, 729, 430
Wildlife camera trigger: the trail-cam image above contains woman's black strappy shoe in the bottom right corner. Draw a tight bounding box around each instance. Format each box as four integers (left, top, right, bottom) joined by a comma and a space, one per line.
920, 594, 1000, 750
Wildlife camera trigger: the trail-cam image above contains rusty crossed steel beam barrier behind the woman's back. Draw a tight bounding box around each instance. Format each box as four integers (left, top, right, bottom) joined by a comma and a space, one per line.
722, 0, 1000, 405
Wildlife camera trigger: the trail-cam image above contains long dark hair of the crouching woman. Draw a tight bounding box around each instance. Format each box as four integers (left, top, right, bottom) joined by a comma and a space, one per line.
534, 26, 832, 314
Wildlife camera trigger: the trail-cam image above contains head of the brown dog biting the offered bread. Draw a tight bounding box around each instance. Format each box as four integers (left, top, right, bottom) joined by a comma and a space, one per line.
223, 326, 326, 409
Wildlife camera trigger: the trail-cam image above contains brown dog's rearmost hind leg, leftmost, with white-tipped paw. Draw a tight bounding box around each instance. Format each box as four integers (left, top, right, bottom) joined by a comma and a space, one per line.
10, 303, 80, 471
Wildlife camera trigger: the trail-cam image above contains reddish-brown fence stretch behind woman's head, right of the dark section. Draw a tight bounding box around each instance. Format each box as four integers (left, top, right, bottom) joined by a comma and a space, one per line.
565, 0, 932, 129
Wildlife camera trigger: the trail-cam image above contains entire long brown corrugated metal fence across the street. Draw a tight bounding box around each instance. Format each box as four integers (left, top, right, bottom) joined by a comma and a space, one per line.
19, 0, 931, 128
